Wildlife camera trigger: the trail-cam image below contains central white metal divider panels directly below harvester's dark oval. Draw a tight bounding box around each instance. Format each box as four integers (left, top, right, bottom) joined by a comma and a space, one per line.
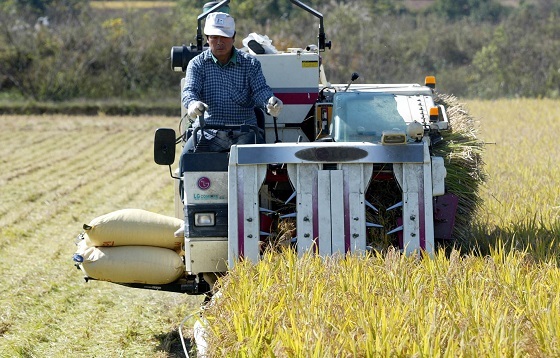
288, 163, 373, 255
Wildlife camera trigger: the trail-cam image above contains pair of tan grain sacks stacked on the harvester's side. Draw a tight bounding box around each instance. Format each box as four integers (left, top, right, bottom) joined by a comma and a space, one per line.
74, 209, 185, 285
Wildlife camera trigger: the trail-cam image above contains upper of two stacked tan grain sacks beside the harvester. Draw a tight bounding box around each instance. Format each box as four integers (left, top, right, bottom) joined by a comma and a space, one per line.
83, 209, 183, 250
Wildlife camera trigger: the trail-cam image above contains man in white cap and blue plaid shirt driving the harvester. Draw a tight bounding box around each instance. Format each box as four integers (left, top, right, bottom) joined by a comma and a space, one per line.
182, 12, 283, 152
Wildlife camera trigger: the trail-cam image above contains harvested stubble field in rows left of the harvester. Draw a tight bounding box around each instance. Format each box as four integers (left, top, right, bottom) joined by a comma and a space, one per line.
0, 116, 197, 357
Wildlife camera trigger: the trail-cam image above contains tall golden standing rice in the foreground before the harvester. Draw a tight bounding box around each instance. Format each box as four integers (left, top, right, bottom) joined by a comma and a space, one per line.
199, 245, 560, 358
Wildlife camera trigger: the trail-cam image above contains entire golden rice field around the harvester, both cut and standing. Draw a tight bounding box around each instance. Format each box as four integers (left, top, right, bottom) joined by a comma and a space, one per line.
0, 99, 560, 357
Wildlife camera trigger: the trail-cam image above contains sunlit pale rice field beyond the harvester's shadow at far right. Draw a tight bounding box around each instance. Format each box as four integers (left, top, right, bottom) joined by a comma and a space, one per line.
468, 99, 560, 227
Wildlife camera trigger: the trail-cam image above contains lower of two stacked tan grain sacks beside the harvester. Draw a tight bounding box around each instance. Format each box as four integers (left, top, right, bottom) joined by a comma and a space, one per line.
76, 243, 185, 285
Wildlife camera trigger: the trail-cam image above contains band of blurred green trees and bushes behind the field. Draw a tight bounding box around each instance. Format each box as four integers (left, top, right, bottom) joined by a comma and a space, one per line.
0, 0, 560, 101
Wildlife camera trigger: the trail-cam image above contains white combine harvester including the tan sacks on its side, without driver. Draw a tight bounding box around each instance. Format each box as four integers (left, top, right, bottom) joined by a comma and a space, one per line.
74, 0, 458, 314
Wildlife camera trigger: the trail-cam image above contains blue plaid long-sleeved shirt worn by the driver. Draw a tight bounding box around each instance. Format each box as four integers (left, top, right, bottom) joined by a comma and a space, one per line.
181, 48, 273, 127
